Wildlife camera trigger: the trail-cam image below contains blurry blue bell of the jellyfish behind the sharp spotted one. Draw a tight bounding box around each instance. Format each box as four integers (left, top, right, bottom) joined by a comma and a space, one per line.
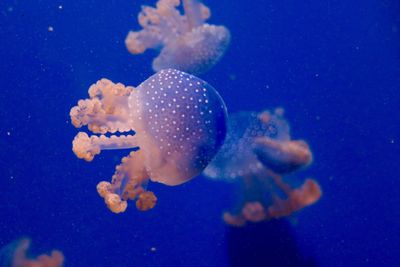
203, 109, 290, 181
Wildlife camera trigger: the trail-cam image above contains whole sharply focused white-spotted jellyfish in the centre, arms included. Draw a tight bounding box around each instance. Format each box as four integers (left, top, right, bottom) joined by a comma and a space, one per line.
70, 69, 227, 213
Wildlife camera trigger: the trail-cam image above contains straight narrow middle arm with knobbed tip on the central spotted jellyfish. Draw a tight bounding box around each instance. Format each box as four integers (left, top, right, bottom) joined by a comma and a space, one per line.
72, 132, 138, 161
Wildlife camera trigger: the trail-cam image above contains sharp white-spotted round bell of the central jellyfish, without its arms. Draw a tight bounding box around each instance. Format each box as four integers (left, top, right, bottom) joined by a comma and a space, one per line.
129, 70, 227, 185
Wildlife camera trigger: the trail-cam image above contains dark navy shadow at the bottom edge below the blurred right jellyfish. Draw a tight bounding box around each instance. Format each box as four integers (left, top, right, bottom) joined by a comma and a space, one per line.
226, 219, 318, 267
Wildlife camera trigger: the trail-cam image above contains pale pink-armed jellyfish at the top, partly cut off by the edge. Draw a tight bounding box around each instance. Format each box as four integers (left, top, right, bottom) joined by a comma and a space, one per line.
125, 0, 230, 75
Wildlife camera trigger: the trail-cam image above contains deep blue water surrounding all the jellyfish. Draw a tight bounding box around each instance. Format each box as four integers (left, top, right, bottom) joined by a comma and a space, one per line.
0, 0, 400, 267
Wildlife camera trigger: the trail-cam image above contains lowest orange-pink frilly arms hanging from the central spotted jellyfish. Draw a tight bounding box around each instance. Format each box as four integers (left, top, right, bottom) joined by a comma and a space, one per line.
97, 150, 157, 213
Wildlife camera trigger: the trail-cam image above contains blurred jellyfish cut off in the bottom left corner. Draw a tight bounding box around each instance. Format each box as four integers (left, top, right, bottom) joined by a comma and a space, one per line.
0, 238, 64, 267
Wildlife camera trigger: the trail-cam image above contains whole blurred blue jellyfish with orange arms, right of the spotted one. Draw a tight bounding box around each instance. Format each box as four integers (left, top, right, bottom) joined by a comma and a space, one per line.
203, 108, 321, 226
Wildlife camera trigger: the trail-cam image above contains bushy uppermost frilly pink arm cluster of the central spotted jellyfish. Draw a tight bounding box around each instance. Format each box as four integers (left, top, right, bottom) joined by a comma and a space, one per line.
70, 79, 134, 134
